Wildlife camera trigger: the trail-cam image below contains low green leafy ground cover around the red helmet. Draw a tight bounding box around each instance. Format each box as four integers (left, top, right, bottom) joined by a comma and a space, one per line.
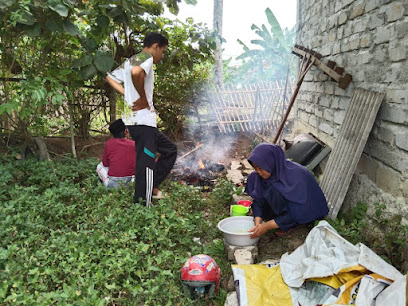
0, 157, 234, 305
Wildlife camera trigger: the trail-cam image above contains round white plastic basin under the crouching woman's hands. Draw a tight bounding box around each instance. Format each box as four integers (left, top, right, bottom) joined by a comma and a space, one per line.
218, 216, 259, 246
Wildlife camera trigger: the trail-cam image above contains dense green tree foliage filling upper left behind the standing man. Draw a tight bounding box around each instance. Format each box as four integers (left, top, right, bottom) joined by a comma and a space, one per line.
0, 0, 212, 143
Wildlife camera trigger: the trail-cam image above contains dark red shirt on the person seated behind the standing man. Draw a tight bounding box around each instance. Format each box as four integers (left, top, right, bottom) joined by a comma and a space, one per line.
102, 138, 136, 177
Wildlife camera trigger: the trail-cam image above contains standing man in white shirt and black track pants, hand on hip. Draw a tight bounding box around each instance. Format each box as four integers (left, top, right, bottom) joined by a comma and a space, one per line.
106, 32, 177, 207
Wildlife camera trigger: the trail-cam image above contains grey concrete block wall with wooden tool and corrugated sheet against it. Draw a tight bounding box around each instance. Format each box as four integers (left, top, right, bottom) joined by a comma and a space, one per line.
294, 0, 408, 220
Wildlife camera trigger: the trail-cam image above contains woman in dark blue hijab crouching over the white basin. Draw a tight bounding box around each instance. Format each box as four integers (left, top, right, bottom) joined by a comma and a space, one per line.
245, 143, 329, 238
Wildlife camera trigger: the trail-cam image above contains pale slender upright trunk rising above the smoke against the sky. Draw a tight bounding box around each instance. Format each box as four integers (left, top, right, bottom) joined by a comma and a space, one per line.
213, 0, 224, 87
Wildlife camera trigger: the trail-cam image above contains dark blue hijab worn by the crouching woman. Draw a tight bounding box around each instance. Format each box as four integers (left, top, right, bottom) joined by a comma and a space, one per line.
246, 143, 317, 204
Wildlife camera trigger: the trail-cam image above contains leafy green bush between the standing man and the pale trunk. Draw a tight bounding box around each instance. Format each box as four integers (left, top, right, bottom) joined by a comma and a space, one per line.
155, 19, 215, 136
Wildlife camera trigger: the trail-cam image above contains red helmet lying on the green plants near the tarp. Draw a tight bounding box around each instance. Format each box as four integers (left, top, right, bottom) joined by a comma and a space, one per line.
180, 254, 221, 298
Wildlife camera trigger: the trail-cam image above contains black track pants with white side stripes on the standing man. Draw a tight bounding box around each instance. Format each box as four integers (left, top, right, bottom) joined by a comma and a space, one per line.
127, 125, 177, 207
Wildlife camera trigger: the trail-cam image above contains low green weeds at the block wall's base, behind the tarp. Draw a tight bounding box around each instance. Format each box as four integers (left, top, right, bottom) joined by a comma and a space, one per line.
328, 203, 408, 271
